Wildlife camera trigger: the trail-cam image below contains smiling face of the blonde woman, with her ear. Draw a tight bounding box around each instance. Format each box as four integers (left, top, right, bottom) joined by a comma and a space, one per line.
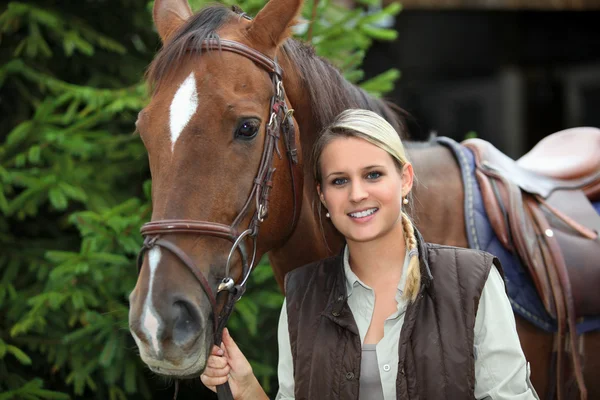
317, 137, 413, 242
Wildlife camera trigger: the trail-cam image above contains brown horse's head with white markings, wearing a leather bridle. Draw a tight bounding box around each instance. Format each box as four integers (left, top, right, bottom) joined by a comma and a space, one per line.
129, 0, 302, 377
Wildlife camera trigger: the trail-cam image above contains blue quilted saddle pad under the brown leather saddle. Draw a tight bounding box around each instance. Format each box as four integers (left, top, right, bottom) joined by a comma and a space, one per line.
436, 137, 600, 334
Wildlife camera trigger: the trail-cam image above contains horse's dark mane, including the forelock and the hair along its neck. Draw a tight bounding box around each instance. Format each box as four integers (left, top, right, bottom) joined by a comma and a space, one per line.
146, 5, 408, 136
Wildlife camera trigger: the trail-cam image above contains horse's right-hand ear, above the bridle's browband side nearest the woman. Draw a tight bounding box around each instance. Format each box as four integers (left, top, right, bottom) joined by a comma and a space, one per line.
248, 0, 302, 49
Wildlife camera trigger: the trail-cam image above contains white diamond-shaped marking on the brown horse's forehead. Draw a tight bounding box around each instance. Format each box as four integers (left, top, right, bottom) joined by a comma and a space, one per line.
169, 72, 198, 151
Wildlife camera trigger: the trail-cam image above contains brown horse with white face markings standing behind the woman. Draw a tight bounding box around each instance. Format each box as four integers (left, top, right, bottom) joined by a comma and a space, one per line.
130, 0, 600, 398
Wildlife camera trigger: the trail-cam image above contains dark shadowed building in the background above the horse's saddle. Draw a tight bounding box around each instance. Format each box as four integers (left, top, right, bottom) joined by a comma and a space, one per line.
365, 0, 600, 157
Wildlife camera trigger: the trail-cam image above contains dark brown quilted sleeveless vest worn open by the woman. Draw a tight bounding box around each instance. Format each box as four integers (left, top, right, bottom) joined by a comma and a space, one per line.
286, 233, 500, 400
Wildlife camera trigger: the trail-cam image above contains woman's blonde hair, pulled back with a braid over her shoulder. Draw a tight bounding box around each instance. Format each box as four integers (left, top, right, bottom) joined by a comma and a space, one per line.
312, 109, 421, 301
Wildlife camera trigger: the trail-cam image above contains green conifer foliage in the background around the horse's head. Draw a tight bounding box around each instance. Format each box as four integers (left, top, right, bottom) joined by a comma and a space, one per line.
0, 0, 400, 400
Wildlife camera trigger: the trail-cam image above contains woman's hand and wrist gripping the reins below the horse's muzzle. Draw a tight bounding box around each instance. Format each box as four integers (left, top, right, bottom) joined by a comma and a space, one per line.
200, 328, 267, 400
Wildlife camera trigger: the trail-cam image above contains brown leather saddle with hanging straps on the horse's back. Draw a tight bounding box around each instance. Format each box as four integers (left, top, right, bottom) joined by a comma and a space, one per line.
462, 128, 600, 398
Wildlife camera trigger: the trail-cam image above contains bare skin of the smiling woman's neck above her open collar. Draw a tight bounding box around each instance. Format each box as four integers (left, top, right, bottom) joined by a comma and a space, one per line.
347, 220, 406, 287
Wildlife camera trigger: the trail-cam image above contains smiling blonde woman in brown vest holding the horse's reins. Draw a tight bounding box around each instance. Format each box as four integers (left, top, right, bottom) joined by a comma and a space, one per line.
201, 110, 537, 400
